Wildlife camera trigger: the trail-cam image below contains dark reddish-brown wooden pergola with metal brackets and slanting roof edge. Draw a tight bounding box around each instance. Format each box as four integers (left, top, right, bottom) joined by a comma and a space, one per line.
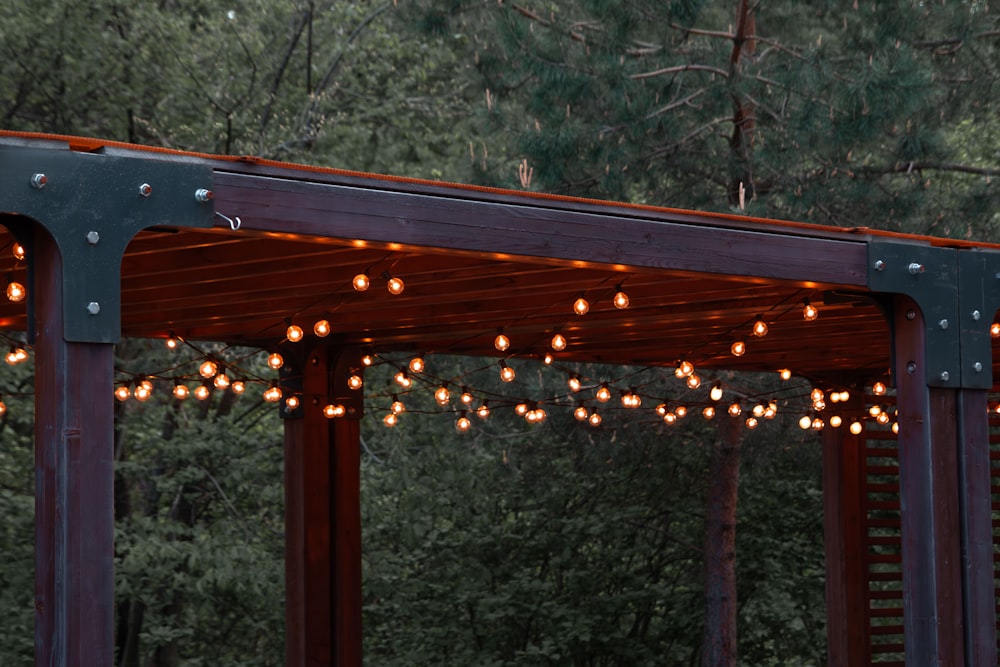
0, 133, 1000, 667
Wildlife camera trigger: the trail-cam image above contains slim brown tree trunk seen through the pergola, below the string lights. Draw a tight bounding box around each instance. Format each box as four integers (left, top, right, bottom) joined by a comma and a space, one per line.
702, 415, 743, 667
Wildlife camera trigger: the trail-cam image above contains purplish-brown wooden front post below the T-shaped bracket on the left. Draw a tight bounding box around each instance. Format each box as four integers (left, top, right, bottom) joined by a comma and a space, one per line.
32, 229, 114, 667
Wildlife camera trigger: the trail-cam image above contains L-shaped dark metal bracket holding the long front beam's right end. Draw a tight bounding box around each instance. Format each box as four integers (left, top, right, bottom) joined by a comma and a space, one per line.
868, 238, 960, 388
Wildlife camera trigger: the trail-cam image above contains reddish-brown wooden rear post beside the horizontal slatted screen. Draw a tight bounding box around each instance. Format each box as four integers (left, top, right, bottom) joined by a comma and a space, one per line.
823, 397, 869, 667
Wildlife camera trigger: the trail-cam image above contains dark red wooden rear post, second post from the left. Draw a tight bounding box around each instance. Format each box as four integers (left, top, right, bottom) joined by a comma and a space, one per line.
285, 345, 362, 667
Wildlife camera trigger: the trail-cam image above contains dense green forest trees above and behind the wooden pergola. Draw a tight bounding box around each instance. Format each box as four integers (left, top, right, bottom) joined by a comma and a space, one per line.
0, 0, 1000, 667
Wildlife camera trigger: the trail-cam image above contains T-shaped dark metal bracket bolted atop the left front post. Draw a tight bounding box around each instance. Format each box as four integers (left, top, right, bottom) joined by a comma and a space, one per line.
0, 145, 214, 343
